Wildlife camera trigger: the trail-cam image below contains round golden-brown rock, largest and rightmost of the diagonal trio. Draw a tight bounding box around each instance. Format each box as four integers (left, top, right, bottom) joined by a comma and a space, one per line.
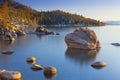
44, 67, 57, 78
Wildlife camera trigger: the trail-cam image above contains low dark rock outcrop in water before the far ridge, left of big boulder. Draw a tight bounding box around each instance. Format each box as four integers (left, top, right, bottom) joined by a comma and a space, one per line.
35, 26, 60, 35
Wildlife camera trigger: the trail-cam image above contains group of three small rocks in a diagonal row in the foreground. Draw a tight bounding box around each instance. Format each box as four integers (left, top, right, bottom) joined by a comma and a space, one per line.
26, 57, 57, 78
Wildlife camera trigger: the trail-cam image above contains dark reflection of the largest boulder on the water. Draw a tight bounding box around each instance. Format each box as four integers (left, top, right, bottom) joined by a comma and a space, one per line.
66, 48, 99, 65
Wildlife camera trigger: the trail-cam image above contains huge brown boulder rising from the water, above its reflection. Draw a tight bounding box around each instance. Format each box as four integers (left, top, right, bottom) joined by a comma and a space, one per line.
65, 29, 101, 49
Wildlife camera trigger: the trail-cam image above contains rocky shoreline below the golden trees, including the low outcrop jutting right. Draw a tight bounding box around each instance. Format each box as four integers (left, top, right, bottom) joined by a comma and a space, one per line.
0, 26, 60, 41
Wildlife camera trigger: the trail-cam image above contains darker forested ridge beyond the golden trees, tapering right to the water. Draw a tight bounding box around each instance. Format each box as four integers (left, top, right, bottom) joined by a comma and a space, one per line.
35, 10, 104, 26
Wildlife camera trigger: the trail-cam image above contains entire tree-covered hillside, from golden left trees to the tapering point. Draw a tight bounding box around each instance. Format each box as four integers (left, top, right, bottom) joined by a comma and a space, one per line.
0, 0, 104, 29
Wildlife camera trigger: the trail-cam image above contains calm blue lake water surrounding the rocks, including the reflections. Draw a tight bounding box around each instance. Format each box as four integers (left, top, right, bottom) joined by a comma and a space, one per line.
0, 26, 120, 80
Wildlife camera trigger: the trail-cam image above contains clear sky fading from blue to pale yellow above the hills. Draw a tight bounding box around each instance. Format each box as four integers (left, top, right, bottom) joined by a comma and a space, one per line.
16, 0, 120, 21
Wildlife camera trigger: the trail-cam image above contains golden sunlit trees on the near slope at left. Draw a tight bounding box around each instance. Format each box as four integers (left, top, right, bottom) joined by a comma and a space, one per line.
0, 2, 37, 30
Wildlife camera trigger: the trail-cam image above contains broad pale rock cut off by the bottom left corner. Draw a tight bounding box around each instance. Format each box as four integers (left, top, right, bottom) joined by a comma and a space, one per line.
0, 70, 22, 80
